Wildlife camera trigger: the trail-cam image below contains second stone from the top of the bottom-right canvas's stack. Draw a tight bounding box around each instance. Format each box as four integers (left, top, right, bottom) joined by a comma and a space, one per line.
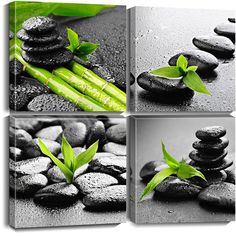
193, 137, 229, 154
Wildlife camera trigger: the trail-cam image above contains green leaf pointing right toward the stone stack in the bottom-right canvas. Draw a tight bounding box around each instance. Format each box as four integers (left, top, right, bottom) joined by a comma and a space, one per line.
177, 161, 207, 181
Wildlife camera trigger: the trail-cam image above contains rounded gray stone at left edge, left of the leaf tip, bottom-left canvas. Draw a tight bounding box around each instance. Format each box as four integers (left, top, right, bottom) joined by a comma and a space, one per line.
9, 127, 32, 148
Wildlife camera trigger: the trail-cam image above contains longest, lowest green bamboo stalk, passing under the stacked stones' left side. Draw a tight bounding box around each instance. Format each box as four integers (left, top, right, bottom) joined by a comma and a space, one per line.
15, 51, 108, 112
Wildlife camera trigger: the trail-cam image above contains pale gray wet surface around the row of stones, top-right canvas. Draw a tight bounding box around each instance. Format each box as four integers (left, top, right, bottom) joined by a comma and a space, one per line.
131, 7, 235, 112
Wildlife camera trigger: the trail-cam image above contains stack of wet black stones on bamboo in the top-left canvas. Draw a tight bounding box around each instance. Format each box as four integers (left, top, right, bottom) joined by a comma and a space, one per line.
17, 16, 73, 68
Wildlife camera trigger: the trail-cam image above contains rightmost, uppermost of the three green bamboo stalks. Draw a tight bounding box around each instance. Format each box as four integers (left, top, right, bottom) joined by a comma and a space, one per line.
70, 61, 126, 105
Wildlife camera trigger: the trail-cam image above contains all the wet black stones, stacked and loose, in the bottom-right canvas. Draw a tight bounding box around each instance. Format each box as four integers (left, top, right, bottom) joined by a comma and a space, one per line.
139, 126, 235, 211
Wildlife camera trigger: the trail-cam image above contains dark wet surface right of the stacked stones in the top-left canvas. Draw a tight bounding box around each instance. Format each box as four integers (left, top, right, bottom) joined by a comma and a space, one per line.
56, 6, 126, 90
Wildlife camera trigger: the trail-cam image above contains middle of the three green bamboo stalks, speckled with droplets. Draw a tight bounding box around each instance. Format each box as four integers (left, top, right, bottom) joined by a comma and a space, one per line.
52, 67, 126, 111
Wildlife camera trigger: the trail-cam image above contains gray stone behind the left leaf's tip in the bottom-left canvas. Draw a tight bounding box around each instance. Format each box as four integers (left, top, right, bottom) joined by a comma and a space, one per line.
23, 138, 61, 157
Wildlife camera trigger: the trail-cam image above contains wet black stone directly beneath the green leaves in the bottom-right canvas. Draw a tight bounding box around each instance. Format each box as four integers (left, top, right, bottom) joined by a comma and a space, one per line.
155, 176, 201, 199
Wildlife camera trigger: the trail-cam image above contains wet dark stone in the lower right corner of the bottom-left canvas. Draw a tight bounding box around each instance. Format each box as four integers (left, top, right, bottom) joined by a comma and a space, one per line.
83, 185, 126, 211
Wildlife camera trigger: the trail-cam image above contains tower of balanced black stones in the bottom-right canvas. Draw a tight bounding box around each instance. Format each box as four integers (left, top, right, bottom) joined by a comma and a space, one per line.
189, 126, 233, 184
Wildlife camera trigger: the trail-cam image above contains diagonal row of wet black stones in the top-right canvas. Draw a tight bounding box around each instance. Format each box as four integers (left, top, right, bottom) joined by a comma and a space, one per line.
137, 18, 235, 103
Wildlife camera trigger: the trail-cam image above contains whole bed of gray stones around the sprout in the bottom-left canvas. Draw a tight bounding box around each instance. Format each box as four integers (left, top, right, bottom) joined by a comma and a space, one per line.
9, 117, 126, 211
